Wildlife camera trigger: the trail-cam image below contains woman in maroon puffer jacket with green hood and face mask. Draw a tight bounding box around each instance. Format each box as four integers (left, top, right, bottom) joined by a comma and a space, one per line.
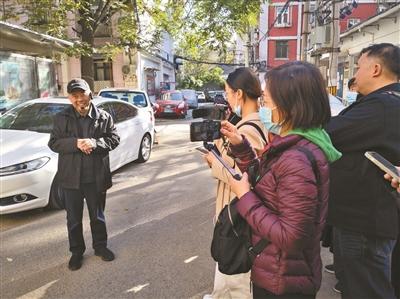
221, 62, 341, 299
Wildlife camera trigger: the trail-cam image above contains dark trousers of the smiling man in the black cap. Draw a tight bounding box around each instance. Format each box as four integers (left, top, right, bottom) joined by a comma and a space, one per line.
63, 183, 107, 255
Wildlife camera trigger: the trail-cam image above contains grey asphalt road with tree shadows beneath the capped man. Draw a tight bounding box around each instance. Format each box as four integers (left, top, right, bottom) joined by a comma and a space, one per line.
0, 120, 339, 298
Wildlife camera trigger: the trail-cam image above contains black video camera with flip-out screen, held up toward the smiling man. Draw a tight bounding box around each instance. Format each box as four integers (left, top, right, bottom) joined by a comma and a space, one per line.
190, 105, 240, 142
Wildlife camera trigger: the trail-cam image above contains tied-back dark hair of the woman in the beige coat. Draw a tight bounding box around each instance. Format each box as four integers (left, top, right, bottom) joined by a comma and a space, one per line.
226, 67, 262, 100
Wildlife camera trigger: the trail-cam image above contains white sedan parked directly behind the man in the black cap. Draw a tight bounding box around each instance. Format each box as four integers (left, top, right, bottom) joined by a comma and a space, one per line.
0, 98, 154, 214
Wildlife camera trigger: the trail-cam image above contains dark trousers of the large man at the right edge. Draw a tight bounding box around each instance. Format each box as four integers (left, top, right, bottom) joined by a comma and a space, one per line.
333, 227, 396, 299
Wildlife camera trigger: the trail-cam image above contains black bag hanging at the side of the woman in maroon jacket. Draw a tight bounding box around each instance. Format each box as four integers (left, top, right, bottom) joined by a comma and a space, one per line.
211, 197, 269, 275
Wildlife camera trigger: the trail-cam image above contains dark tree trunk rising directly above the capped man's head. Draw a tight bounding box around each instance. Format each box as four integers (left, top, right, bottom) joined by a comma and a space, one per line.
81, 22, 94, 91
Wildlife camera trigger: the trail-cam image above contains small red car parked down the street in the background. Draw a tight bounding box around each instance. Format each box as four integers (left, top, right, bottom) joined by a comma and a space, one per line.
156, 90, 188, 117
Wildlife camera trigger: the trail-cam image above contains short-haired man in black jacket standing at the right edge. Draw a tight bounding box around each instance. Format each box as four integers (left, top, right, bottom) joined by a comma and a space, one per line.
327, 43, 400, 298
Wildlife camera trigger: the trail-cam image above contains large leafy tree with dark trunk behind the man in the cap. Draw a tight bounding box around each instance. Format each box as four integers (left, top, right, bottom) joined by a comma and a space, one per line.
2, 0, 184, 87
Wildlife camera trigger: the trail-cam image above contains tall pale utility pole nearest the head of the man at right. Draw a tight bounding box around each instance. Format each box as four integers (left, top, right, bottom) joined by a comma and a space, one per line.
328, 0, 341, 95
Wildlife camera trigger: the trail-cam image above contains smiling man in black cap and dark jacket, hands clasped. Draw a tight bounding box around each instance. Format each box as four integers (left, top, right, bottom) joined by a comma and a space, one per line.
49, 79, 119, 271
